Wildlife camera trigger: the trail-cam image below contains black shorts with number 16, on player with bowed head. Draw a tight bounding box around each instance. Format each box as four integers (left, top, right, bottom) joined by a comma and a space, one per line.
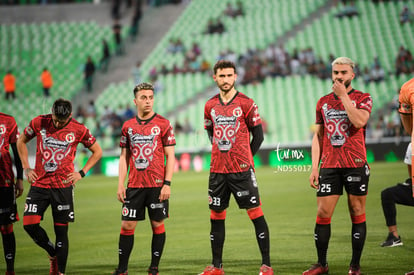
24, 186, 75, 223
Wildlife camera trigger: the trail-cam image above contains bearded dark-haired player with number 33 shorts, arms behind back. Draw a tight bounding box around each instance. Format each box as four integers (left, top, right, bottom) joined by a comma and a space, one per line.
201, 60, 273, 275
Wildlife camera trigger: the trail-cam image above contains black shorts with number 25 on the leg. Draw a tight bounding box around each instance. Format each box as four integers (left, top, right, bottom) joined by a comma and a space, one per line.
317, 164, 370, 197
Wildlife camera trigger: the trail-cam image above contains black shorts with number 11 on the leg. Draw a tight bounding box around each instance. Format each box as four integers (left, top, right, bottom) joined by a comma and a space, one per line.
122, 187, 168, 221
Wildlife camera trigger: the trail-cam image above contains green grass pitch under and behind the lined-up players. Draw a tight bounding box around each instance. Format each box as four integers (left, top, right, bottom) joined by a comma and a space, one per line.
0, 162, 414, 275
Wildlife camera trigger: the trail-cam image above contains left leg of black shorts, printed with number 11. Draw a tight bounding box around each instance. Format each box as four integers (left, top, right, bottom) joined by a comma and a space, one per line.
122, 188, 146, 221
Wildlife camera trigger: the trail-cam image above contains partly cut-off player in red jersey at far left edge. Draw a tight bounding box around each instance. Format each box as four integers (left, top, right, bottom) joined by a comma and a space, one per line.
0, 113, 23, 275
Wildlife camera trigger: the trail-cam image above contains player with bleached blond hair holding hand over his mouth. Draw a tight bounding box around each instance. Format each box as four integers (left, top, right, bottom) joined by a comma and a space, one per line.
303, 57, 372, 275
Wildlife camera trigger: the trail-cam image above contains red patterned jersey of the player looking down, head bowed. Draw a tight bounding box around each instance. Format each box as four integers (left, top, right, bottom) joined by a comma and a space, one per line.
24, 114, 96, 188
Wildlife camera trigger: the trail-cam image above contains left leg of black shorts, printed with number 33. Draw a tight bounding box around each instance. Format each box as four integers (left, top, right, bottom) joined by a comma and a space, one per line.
208, 173, 231, 211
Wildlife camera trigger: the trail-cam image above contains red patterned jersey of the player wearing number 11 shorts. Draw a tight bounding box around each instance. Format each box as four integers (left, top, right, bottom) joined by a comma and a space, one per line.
119, 114, 175, 188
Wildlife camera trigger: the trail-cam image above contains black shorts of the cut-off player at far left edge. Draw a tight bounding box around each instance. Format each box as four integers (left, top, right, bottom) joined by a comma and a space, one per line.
0, 185, 19, 225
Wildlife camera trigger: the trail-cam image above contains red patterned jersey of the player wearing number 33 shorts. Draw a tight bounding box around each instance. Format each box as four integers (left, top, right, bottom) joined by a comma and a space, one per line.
204, 92, 262, 173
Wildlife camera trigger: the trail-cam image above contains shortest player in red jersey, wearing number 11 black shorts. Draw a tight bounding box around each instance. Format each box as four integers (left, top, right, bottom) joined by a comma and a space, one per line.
112, 83, 175, 275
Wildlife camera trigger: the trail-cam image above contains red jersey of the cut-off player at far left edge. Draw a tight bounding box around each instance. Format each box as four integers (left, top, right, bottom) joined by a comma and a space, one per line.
0, 113, 19, 187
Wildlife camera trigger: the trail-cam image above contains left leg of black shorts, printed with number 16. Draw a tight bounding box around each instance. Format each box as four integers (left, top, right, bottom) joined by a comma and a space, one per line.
24, 186, 51, 219
